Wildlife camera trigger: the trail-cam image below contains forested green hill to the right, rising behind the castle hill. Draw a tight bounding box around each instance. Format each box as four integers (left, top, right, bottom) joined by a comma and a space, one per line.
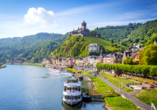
95, 20, 157, 46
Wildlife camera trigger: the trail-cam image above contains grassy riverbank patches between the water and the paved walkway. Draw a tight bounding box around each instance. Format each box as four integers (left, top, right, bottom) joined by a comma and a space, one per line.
68, 69, 140, 110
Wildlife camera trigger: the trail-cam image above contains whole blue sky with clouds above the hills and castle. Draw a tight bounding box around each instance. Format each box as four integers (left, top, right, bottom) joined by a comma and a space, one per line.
0, 0, 157, 38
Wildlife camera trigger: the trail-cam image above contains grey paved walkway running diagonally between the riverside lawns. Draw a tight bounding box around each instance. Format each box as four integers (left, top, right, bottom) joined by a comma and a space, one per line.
98, 76, 151, 110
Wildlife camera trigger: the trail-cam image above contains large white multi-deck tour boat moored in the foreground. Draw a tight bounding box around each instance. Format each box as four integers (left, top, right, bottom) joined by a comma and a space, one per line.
62, 76, 82, 105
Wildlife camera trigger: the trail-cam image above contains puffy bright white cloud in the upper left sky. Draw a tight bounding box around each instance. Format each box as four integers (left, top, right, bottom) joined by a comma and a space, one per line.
24, 7, 56, 26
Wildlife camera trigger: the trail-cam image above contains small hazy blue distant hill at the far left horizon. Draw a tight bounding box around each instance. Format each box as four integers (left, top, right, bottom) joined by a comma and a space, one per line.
0, 37, 21, 45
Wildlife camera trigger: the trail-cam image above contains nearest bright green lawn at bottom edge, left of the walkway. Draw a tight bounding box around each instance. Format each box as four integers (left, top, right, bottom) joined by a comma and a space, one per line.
105, 96, 141, 110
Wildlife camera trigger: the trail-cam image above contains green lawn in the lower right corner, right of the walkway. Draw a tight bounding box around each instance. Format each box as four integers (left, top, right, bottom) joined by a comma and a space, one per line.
136, 90, 157, 107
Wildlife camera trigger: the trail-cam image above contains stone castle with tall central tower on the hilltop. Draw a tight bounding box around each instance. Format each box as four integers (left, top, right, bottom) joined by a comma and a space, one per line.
69, 21, 101, 38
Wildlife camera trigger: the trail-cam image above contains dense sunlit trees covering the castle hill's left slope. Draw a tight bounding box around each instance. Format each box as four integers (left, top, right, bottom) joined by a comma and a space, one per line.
53, 36, 88, 57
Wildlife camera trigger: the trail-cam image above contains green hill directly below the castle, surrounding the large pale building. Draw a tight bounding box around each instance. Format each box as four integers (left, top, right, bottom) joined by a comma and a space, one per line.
52, 36, 126, 57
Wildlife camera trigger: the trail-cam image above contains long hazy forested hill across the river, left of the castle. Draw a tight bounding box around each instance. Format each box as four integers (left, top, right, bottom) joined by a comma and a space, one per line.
0, 33, 68, 62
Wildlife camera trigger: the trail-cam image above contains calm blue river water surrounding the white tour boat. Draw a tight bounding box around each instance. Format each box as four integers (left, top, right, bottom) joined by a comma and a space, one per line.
0, 65, 105, 110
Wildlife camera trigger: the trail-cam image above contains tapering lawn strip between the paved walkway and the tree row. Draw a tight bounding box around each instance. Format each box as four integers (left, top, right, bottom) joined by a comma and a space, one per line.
99, 72, 135, 93
